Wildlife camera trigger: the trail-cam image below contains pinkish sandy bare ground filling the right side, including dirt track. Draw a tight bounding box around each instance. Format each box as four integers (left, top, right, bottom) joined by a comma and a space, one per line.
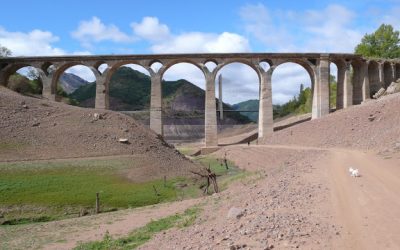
0, 88, 400, 249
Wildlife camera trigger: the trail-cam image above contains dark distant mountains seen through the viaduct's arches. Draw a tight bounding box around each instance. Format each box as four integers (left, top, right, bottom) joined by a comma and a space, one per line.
69, 67, 251, 124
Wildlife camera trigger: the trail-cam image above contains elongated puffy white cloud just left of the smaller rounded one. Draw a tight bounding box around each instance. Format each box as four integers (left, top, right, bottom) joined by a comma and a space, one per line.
71, 17, 134, 48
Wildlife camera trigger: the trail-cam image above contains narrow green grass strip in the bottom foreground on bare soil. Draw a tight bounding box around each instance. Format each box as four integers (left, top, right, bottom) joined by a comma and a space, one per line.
75, 207, 200, 250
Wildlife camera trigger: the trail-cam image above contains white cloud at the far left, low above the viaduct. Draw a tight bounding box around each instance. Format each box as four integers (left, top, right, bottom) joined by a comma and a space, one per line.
0, 26, 66, 56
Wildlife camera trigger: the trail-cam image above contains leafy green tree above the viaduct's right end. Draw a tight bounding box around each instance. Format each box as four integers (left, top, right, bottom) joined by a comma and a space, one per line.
355, 24, 400, 58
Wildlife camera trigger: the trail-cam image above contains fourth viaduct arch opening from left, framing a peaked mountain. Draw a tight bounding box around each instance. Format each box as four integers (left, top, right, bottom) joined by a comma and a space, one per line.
162, 62, 205, 142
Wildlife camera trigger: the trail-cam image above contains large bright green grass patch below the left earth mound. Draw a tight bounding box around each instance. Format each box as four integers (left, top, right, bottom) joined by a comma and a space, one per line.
0, 158, 198, 224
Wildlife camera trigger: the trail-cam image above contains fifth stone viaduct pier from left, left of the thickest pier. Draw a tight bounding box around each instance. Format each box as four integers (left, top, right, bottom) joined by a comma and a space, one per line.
258, 67, 274, 138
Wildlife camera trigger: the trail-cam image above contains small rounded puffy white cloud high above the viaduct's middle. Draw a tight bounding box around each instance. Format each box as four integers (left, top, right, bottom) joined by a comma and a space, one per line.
131, 17, 170, 41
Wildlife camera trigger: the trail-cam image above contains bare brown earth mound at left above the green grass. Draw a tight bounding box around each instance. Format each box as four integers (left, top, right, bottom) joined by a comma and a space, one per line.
0, 87, 197, 179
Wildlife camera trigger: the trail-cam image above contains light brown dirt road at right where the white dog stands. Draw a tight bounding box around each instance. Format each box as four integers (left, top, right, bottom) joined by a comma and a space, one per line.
321, 150, 400, 249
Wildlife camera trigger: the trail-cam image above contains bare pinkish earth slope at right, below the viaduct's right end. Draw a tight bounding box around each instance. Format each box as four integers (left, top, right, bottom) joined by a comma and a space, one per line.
265, 93, 400, 152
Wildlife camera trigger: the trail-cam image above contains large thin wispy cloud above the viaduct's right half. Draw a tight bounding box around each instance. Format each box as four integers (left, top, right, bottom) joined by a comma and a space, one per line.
240, 4, 363, 52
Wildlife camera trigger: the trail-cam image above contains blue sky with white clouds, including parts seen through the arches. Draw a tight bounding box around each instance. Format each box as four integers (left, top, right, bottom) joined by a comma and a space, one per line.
0, 0, 400, 103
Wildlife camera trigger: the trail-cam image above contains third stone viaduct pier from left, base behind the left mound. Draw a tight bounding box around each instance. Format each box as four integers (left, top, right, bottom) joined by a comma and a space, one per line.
150, 72, 164, 135
